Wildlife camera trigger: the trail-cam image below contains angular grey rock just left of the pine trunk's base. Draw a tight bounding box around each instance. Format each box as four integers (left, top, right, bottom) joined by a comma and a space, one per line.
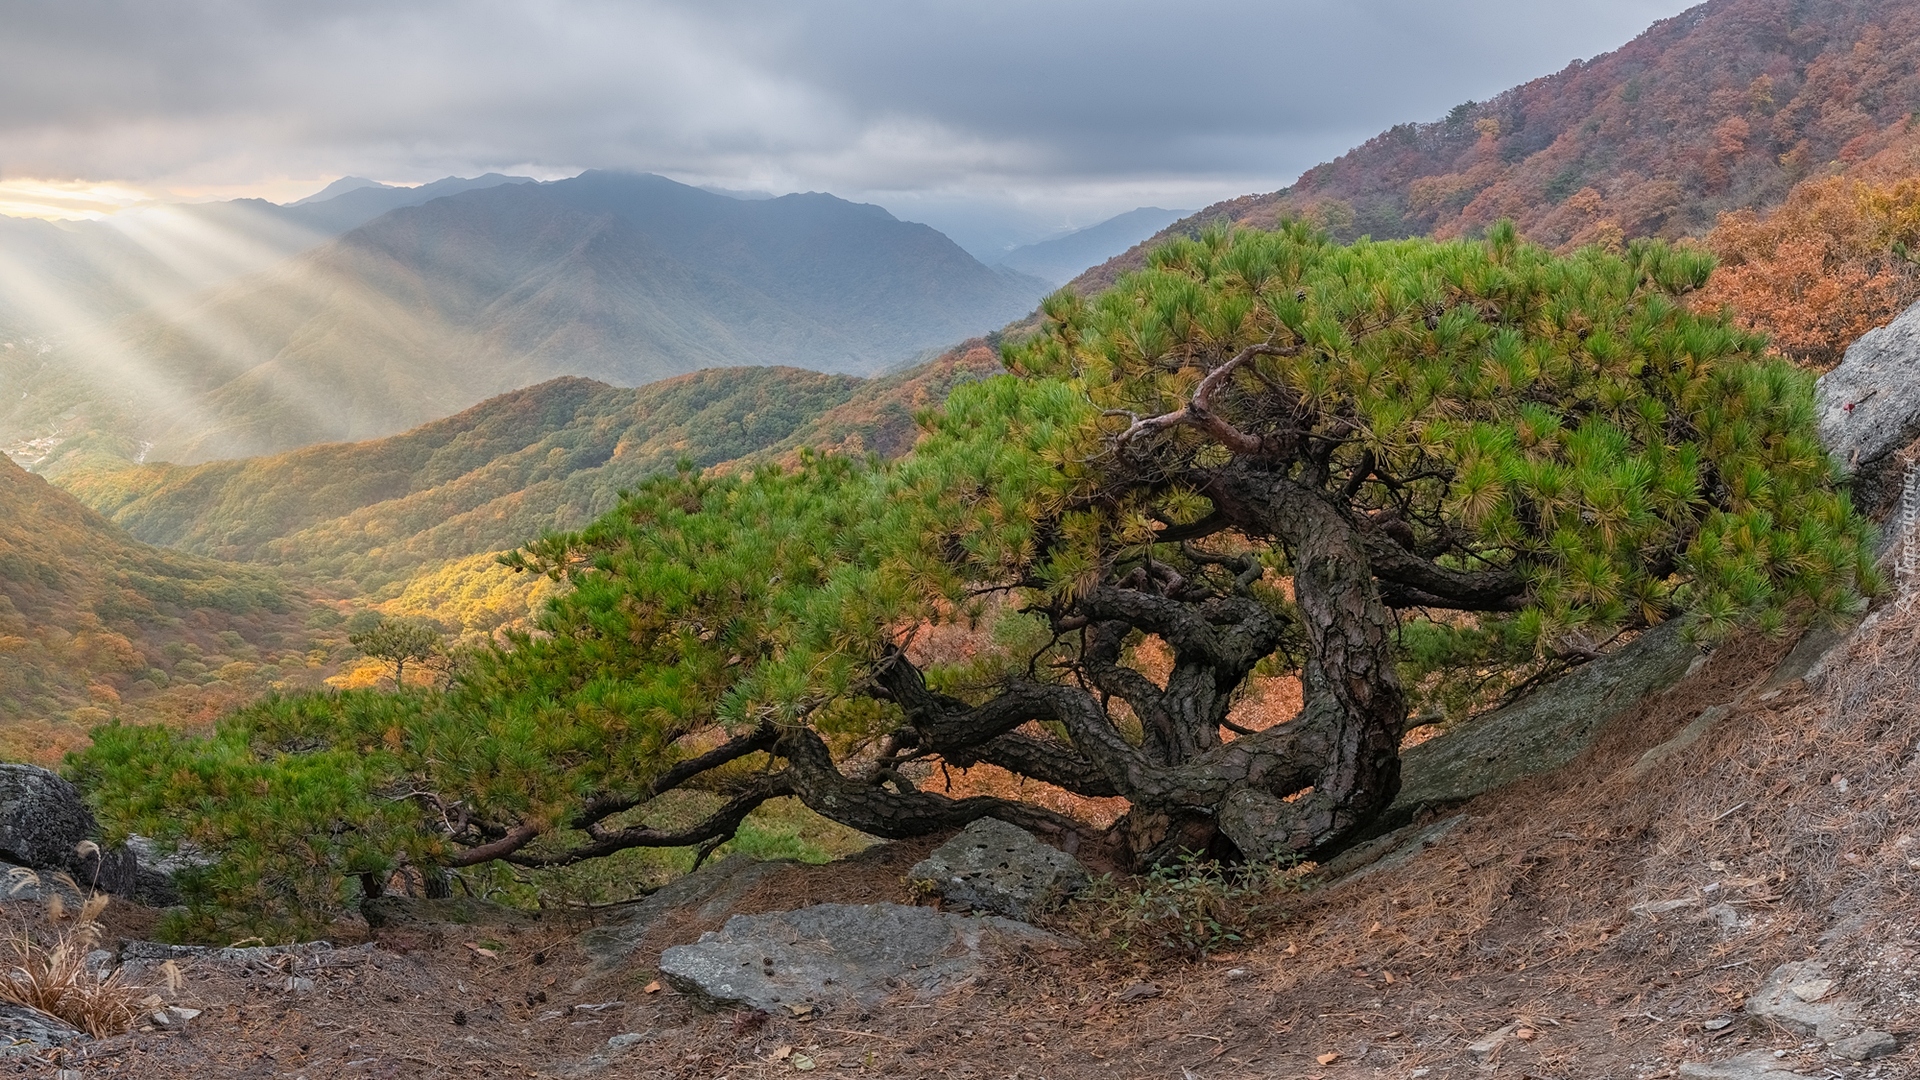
908, 817, 1089, 919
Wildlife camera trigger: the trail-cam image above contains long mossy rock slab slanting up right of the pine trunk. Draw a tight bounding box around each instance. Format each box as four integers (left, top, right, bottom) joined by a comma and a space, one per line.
1386, 619, 1699, 822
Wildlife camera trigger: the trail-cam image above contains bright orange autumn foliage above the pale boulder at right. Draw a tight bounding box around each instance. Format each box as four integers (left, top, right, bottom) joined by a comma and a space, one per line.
1701, 177, 1920, 371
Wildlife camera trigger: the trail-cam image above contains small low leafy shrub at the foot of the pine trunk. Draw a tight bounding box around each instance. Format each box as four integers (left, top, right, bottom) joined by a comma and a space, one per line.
1066, 853, 1300, 961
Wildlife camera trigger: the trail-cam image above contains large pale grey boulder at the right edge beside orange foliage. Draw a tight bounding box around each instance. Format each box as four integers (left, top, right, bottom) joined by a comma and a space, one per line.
1814, 294, 1920, 513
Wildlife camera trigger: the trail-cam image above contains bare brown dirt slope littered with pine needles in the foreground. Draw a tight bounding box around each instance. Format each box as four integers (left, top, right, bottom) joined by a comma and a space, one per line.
10, 609, 1920, 1080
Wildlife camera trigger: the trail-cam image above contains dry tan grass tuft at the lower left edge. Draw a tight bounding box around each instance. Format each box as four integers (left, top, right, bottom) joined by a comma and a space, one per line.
0, 896, 146, 1038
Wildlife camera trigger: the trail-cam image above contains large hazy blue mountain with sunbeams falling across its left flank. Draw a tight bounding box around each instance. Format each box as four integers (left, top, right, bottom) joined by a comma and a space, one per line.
60, 173, 1044, 461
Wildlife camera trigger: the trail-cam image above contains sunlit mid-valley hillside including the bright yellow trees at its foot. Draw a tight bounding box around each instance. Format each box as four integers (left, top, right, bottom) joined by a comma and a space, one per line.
56, 342, 1000, 632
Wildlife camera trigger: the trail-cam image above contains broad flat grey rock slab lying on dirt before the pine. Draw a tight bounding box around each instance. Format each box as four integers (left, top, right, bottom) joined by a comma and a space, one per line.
660, 903, 1075, 1017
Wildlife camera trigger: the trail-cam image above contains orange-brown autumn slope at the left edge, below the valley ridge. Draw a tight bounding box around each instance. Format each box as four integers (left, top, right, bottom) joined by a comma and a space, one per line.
0, 449, 309, 761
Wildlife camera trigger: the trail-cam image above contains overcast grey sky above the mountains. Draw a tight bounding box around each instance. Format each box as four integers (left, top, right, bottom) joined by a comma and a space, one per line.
11, 0, 1688, 246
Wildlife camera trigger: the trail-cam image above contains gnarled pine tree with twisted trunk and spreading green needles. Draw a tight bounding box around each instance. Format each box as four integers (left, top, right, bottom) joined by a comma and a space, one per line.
81, 225, 1872, 926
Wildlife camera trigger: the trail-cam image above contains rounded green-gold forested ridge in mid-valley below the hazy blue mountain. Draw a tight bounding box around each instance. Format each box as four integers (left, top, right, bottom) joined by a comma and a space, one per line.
60, 367, 860, 588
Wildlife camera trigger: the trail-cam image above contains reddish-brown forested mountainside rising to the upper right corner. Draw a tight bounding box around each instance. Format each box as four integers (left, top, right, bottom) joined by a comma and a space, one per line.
1073, 0, 1920, 292
